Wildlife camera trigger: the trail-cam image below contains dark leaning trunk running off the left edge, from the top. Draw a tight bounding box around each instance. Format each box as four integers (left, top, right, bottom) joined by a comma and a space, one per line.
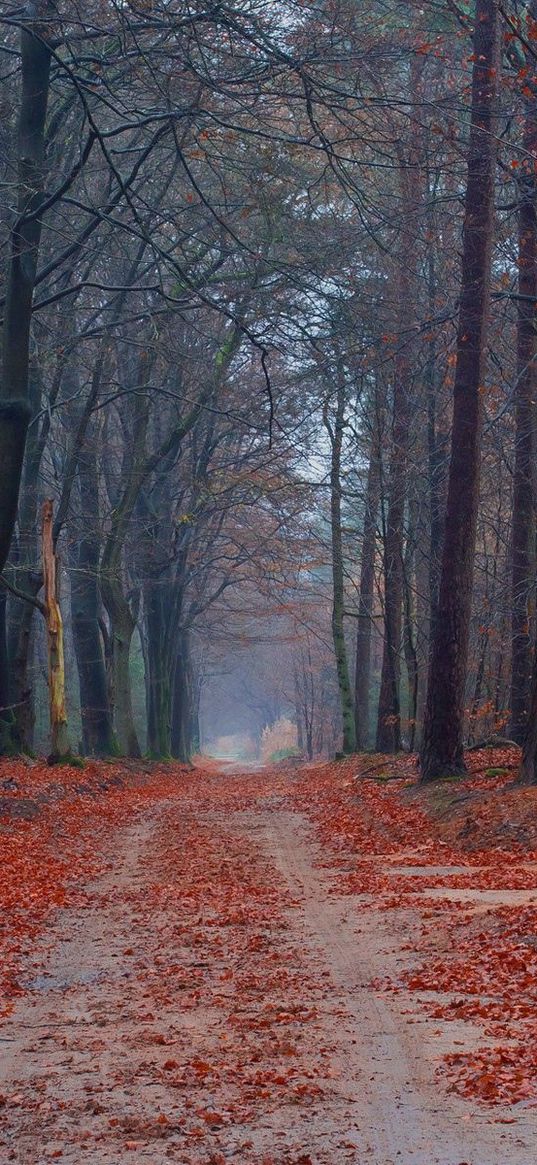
0, 0, 54, 571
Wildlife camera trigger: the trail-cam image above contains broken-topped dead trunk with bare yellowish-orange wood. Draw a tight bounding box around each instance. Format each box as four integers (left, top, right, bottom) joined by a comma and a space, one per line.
43, 501, 72, 763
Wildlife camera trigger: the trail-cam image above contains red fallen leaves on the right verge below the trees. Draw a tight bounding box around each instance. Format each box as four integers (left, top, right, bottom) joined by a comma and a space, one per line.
284, 748, 537, 1104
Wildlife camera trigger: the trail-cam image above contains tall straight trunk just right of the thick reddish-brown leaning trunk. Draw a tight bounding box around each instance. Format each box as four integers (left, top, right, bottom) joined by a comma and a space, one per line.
509, 45, 537, 742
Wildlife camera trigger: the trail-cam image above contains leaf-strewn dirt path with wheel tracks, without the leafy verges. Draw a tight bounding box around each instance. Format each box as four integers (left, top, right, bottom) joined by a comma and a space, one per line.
0, 771, 537, 1165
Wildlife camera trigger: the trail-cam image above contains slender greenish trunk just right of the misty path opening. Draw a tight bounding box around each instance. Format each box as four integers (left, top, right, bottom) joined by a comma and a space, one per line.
354, 401, 380, 749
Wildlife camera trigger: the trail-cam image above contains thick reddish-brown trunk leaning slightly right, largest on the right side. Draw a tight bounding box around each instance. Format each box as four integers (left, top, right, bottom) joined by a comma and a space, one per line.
421, 0, 500, 781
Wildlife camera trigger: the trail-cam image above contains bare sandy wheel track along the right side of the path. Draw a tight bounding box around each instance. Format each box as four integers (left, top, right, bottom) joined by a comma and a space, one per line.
236, 797, 537, 1165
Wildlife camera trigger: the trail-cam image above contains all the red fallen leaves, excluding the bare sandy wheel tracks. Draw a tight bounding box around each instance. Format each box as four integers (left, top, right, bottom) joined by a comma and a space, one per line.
0, 754, 537, 1137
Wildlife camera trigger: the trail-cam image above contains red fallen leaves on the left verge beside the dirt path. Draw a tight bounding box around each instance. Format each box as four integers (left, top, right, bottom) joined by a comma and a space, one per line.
0, 758, 186, 1015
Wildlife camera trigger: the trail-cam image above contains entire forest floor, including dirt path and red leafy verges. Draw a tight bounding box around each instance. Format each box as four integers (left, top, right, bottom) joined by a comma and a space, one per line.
0, 750, 537, 1165
